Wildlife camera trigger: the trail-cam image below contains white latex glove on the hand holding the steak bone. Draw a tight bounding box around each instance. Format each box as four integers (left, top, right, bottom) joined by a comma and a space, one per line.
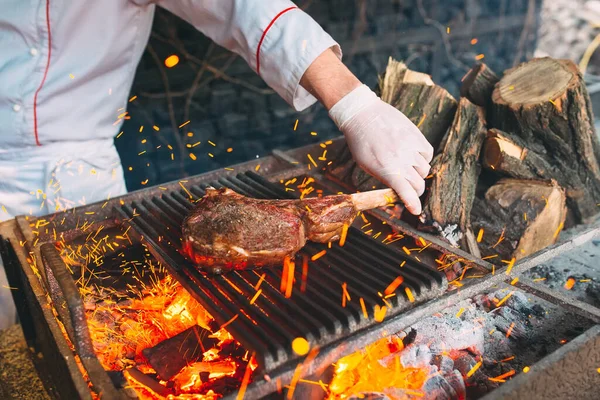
329, 85, 433, 215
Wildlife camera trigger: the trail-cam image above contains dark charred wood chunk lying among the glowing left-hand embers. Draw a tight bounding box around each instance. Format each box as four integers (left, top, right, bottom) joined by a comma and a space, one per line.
142, 325, 218, 380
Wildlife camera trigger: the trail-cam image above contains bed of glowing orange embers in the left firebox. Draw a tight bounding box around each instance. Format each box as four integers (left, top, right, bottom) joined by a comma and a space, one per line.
57, 227, 261, 400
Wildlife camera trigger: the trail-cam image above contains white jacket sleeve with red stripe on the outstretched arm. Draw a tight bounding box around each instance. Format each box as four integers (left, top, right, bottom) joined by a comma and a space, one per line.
157, 0, 342, 111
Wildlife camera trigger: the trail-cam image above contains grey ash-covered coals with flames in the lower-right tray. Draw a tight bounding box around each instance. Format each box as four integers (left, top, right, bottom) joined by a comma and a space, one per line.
334, 287, 588, 400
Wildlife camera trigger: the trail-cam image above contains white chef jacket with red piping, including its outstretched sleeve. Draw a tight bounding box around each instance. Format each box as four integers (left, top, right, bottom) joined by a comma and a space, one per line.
0, 0, 341, 220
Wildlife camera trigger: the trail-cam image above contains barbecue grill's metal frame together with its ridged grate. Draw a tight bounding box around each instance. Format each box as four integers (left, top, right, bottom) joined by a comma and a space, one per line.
0, 140, 600, 398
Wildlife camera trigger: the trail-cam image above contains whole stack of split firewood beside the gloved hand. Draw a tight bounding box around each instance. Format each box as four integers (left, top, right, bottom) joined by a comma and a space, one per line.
331, 58, 600, 260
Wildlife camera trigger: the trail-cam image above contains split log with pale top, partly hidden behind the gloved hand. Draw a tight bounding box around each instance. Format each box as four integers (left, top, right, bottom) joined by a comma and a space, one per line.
329, 57, 457, 191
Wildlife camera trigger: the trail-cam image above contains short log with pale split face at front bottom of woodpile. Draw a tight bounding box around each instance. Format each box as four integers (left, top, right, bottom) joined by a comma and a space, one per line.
471, 178, 567, 264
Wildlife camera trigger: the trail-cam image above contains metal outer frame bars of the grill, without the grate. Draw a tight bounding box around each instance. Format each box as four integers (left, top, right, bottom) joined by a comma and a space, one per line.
0, 139, 600, 399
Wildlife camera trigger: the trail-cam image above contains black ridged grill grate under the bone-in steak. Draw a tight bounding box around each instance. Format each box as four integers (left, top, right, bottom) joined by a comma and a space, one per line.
115, 172, 447, 372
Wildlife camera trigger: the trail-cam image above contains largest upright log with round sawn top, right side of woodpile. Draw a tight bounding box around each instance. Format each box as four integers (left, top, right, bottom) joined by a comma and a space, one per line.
484, 58, 600, 222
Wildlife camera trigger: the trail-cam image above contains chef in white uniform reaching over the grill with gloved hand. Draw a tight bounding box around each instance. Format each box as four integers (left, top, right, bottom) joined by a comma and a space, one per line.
0, 0, 433, 328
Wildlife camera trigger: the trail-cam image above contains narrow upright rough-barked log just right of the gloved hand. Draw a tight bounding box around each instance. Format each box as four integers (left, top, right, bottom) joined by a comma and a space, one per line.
421, 98, 487, 252
